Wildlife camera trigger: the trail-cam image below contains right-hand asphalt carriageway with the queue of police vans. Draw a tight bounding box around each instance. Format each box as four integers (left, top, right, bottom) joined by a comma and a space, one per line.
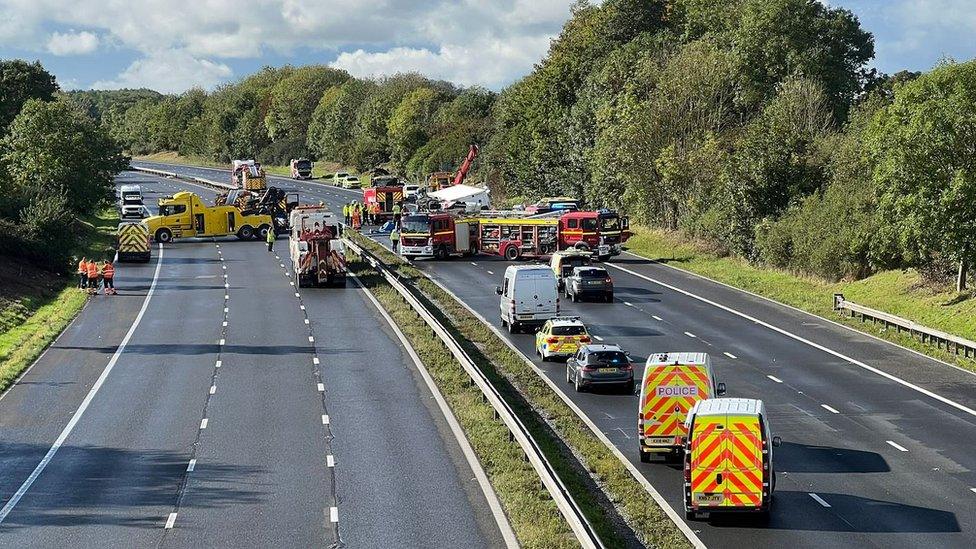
136, 162, 976, 547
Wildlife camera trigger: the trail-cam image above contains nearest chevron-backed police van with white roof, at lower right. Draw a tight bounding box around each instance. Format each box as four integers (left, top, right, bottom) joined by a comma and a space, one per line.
684, 398, 780, 520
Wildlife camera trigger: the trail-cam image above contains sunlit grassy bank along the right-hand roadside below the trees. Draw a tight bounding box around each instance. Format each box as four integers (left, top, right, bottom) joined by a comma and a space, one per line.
627, 228, 976, 370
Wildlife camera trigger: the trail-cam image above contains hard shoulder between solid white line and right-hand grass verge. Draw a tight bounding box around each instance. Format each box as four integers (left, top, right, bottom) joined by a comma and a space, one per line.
611, 254, 976, 409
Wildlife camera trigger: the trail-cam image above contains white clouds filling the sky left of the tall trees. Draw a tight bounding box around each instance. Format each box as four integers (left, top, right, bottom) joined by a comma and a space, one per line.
0, 0, 573, 92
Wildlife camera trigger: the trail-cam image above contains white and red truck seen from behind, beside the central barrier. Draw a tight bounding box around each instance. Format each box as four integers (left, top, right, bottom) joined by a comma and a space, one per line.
288, 206, 346, 288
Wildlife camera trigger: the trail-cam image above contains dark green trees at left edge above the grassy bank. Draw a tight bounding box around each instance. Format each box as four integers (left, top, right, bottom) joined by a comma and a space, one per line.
0, 60, 128, 272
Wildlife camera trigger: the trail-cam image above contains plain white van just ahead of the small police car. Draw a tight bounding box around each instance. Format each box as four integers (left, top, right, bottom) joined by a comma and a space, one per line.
495, 265, 559, 333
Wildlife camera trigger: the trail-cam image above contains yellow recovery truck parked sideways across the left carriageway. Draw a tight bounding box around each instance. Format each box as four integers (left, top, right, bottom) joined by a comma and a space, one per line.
145, 191, 272, 242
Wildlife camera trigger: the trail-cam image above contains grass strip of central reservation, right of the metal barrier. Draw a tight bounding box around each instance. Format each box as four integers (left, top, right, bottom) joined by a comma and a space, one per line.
347, 231, 690, 548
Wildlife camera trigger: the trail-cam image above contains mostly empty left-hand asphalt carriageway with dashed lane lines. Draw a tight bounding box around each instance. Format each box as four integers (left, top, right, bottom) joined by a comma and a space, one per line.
0, 172, 510, 548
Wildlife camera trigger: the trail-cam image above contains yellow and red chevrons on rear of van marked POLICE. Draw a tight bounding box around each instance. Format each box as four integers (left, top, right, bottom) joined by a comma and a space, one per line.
641, 365, 709, 437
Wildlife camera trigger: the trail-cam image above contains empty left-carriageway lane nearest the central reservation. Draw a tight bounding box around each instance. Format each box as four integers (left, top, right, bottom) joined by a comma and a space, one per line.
304, 263, 504, 547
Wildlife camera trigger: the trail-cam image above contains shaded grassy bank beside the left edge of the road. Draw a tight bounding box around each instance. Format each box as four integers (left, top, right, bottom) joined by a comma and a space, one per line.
0, 208, 118, 392
